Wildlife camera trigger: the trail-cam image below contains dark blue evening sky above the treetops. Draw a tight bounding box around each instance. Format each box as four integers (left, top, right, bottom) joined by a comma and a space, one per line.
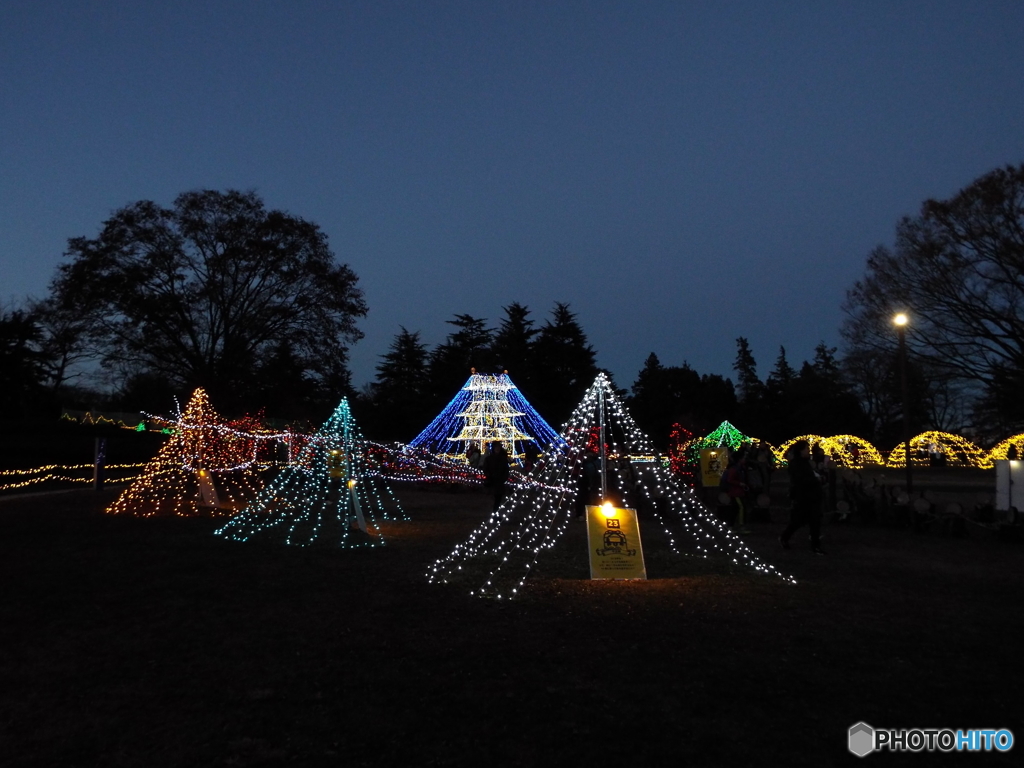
0, 0, 1024, 386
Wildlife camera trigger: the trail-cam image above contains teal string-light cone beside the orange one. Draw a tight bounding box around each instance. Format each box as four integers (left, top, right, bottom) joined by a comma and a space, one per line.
216, 399, 409, 548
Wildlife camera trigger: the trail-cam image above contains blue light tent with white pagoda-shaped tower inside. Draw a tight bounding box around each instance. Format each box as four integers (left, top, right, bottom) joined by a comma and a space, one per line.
409, 372, 561, 463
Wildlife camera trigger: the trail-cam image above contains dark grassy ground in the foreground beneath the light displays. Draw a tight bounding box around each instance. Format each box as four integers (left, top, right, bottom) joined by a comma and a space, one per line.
0, 488, 1024, 768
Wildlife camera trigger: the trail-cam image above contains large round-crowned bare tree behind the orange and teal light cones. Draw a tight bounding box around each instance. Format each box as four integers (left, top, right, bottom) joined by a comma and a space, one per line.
52, 190, 367, 417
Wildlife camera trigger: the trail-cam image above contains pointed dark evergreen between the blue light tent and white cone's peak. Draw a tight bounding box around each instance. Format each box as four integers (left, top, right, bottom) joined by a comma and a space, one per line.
532, 302, 598, 426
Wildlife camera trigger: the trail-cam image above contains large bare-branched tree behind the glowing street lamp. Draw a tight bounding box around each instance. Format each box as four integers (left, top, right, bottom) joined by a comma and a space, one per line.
843, 164, 1024, 432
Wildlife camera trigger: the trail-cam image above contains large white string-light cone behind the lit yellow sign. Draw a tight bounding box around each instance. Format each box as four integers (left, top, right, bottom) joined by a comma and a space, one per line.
427, 374, 795, 599
